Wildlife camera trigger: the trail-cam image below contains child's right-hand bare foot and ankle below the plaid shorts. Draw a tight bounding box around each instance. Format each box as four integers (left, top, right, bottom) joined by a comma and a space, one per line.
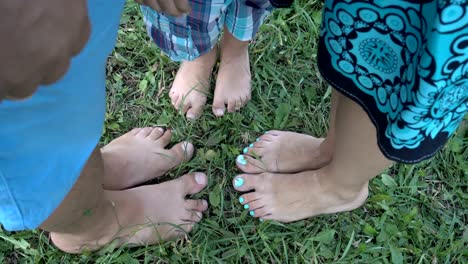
213, 29, 251, 116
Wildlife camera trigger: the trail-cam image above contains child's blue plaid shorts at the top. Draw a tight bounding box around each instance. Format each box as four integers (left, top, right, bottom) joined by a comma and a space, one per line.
141, 0, 273, 61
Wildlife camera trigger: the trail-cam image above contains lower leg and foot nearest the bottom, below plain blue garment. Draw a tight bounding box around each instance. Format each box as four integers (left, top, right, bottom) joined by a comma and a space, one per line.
41, 148, 207, 253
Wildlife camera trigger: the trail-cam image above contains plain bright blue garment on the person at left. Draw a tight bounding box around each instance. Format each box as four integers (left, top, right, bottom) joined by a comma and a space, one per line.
0, 0, 124, 231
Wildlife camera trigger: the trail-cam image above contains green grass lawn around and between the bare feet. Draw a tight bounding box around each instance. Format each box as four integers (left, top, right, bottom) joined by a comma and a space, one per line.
0, 0, 468, 264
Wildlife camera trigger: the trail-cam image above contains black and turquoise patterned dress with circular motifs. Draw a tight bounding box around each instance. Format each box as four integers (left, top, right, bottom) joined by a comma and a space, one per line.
318, 0, 468, 163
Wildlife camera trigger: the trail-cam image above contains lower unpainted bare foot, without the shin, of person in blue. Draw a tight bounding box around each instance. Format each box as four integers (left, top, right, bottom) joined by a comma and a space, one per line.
51, 173, 208, 253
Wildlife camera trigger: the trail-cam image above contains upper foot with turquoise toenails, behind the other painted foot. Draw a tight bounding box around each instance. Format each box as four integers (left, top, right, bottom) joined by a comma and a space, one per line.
236, 130, 332, 173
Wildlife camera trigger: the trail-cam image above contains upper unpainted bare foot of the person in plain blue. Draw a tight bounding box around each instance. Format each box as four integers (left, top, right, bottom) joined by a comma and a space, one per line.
101, 127, 194, 190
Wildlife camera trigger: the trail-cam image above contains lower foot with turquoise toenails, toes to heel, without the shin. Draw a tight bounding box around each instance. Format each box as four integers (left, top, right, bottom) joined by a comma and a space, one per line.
233, 170, 368, 223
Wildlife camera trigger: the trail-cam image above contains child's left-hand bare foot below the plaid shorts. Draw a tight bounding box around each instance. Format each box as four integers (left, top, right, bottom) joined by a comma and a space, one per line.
169, 46, 217, 120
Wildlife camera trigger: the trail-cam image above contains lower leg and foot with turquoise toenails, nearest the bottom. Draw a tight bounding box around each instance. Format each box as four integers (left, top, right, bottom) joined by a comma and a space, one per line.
233, 93, 392, 222
